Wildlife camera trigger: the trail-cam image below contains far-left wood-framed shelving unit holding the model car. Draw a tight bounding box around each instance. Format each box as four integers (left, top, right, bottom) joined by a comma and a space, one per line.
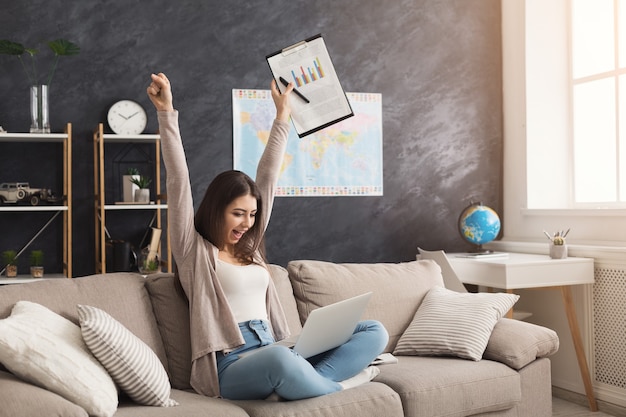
0, 123, 72, 284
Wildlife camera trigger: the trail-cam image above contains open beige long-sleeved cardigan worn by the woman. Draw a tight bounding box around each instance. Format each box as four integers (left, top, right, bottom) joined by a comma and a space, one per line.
158, 111, 289, 397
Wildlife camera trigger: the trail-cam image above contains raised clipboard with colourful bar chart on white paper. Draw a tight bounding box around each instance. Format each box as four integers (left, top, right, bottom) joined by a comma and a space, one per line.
265, 34, 354, 138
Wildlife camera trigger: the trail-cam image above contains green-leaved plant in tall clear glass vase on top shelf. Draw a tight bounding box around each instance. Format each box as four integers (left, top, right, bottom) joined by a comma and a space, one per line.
0, 39, 80, 133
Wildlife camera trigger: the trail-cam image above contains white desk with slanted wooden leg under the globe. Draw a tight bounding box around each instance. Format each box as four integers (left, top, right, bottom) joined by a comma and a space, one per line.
448, 253, 598, 411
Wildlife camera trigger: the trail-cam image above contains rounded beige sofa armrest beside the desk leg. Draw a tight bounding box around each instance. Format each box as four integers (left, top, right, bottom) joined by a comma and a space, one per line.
483, 318, 559, 369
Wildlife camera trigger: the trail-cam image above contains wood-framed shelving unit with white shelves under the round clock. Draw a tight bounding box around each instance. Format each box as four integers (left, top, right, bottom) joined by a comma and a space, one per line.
93, 123, 173, 274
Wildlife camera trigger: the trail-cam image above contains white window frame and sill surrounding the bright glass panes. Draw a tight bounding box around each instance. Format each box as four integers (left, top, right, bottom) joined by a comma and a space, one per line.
501, 0, 626, 245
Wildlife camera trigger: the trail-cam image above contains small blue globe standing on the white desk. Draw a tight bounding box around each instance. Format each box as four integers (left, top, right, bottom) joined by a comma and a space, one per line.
459, 203, 500, 250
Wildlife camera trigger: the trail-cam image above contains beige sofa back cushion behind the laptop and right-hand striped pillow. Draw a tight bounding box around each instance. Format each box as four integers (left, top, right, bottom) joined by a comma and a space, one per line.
287, 260, 443, 351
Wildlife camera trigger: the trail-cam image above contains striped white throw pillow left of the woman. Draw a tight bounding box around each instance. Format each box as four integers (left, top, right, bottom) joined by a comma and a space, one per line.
78, 305, 178, 407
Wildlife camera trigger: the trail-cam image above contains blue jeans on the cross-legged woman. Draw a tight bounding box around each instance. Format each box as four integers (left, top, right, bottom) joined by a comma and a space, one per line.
217, 320, 389, 400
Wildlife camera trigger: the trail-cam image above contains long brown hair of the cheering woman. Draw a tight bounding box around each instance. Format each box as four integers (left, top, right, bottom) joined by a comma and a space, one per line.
194, 170, 265, 263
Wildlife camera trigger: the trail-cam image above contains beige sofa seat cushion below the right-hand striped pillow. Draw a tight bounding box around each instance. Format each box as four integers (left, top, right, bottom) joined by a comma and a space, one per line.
375, 356, 521, 417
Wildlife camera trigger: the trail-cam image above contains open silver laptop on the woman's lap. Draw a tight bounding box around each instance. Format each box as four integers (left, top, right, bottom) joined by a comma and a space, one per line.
239, 292, 372, 358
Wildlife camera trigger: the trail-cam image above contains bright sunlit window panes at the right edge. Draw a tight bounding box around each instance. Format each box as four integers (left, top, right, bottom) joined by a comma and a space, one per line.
570, 0, 626, 208
